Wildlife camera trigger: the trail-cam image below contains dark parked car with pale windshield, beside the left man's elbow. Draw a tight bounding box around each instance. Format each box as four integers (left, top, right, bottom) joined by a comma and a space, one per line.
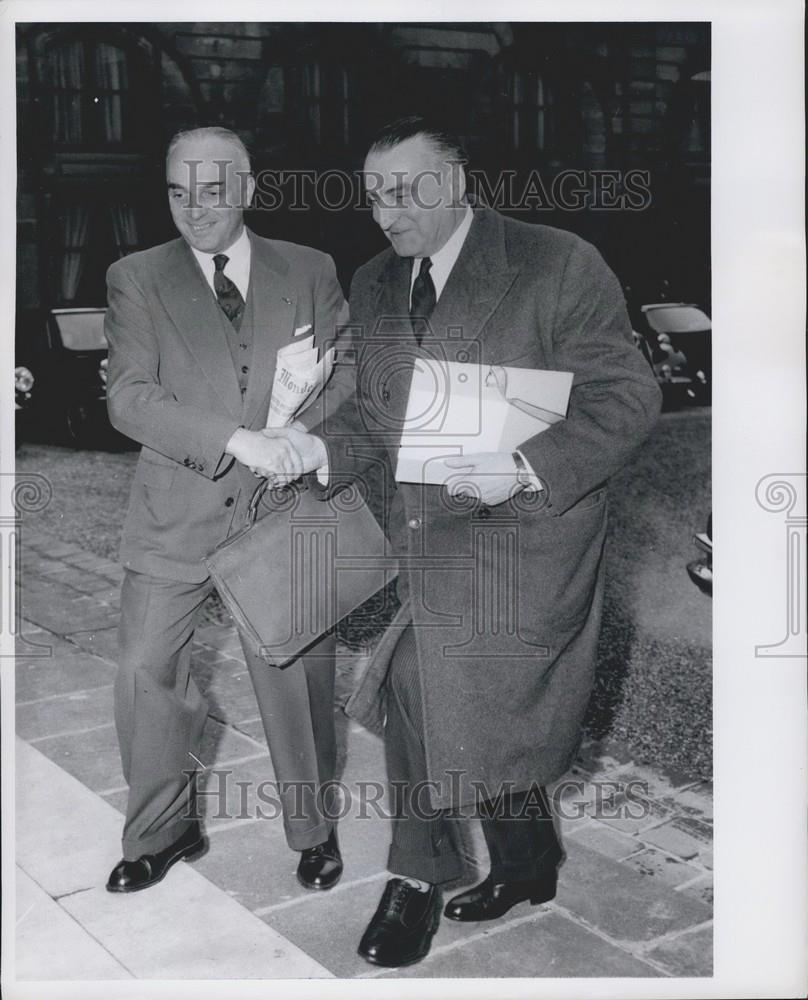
41, 308, 111, 445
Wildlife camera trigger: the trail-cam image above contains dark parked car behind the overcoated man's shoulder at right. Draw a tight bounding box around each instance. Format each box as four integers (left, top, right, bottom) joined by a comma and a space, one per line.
634, 302, 712, 407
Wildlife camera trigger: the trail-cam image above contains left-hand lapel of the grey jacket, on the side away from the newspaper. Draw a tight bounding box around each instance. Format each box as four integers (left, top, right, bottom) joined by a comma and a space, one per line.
158, 240, 241, 419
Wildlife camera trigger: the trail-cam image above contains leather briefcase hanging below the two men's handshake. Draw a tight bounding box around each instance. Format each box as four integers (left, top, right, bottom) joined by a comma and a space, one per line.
204, 481, 398, 667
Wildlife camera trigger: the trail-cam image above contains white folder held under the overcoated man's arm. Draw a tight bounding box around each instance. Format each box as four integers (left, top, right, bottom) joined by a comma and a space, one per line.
396, 359, 573, 485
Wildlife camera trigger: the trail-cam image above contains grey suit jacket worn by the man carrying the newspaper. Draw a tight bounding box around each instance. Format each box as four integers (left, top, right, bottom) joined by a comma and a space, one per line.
105, 232, 347, 582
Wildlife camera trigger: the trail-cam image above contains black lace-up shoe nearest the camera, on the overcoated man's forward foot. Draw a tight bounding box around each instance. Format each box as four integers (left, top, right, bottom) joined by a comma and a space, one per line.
358, 878, 442, 968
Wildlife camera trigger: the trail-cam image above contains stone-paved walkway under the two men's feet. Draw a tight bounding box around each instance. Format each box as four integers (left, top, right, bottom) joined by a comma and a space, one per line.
15, 531, 712, 980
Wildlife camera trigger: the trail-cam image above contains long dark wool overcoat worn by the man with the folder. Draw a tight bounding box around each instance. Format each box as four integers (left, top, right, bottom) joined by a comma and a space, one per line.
314, 208, 660, 806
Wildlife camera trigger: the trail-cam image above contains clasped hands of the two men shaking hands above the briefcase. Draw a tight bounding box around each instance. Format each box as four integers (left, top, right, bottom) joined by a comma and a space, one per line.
225, 424, 328, 486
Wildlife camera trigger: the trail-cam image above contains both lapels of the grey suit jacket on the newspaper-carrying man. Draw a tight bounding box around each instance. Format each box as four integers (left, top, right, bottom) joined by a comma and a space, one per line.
158, 230, 297, 426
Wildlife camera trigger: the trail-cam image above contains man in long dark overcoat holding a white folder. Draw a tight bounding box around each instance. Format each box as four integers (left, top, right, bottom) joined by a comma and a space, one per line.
272, 118, 660, 966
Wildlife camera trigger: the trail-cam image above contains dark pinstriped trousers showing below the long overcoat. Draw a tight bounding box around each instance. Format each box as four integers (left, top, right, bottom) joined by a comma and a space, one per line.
385, 625, 560, 883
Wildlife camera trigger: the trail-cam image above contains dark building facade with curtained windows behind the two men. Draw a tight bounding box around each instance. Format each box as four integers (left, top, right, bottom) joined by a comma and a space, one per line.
12, 22, 710, 337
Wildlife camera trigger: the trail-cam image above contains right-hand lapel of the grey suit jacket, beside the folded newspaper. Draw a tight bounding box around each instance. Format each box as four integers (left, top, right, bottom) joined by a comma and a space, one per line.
244, 233, 297, 427
